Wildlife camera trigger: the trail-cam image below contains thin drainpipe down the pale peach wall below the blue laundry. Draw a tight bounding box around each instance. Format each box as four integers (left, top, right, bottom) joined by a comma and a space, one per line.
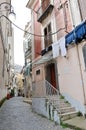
76, 45, 86, 118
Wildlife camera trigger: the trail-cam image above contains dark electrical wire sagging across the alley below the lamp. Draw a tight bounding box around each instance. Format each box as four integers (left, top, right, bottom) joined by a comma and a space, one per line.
0, 15, 65, 37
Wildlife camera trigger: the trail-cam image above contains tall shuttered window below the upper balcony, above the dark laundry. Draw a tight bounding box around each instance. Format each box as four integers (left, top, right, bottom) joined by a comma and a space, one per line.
44, 23, 52, 48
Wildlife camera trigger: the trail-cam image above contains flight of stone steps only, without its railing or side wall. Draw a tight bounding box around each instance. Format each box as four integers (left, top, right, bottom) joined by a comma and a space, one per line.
48, 95, 77, 121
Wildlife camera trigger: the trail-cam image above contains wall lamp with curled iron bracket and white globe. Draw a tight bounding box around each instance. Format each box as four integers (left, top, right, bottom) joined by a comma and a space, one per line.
0, 2, 16, 21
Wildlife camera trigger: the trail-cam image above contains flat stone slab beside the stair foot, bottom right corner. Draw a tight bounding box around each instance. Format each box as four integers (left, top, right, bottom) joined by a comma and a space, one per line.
63, 116, 86, 130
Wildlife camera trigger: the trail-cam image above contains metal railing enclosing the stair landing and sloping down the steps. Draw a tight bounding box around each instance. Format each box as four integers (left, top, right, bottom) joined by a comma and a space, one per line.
32, 80, 60, 113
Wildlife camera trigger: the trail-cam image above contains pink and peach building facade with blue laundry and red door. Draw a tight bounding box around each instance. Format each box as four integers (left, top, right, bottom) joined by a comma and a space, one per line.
27, 0, 86, 118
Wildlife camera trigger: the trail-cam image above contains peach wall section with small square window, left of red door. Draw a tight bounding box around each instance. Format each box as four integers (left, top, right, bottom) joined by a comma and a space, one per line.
33, 64, 45, 97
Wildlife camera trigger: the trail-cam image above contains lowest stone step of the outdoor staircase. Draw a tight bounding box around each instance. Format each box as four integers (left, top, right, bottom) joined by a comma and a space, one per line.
59, 111, 77, 121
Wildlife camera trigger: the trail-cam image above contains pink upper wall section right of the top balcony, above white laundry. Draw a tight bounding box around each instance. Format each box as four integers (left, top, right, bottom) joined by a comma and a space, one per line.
52, 0, 73, 39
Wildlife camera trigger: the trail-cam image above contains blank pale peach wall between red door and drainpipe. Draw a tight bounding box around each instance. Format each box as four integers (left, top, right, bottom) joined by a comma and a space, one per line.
57, 46, 84, 104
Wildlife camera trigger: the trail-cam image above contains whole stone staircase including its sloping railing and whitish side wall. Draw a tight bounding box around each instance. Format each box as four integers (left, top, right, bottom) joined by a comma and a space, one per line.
45, 80, 78, 123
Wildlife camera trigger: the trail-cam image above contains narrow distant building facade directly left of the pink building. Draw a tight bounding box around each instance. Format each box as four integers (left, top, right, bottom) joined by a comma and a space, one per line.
23, 22, 32, 98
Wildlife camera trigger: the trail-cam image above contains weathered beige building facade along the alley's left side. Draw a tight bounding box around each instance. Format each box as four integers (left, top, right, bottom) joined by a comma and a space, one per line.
0, 0, 14, 100
